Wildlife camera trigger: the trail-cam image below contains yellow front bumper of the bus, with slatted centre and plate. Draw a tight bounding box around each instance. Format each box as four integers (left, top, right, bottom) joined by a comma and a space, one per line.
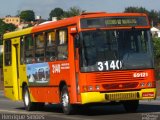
81, 88, 156, 104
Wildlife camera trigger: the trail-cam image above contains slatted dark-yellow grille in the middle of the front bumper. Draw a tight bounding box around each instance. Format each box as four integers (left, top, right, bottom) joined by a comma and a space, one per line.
105, 92, 139, 101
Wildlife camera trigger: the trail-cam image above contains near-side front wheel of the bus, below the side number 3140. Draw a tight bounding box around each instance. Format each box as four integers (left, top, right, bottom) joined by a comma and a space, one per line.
61, 86, 75, 115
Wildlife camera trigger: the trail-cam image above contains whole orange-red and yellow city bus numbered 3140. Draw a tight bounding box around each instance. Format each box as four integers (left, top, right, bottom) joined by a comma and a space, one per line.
3, 12, 156, 114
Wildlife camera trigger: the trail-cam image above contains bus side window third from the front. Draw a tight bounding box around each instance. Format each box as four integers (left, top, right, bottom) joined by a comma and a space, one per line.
35, 33, 45, 62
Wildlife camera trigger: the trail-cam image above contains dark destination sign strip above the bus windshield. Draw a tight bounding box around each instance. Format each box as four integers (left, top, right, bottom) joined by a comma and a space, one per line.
81, 16, 148, 28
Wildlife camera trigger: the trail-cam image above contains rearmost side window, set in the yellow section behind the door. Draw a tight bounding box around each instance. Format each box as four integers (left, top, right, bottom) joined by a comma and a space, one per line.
4, 40, 12, 66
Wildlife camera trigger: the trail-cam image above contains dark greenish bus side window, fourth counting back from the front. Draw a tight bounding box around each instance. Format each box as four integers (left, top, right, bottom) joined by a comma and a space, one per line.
24, 35, 35, 64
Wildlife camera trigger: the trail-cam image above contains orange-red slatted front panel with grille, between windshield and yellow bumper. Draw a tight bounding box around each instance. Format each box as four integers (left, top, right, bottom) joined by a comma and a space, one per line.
86, 70, 146, 91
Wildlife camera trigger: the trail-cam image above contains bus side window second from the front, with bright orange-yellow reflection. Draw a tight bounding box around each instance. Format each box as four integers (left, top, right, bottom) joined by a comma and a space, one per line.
46, 30, 56, 61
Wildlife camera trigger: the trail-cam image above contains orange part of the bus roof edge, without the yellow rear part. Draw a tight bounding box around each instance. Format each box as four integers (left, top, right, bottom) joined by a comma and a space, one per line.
32, 12, 147, 33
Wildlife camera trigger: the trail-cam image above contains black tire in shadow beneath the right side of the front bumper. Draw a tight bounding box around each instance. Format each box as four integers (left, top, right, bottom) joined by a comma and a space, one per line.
123, 100, 139, 113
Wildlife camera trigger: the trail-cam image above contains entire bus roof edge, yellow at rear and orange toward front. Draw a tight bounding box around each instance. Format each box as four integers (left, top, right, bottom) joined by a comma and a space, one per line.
3, 12, 147, 39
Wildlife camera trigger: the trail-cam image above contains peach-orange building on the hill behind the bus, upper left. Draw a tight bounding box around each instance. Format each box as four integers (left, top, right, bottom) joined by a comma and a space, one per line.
3, 16, 21, 26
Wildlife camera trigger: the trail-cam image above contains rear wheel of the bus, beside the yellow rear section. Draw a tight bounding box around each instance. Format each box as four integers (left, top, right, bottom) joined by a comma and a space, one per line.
23, 86, 37, 111
